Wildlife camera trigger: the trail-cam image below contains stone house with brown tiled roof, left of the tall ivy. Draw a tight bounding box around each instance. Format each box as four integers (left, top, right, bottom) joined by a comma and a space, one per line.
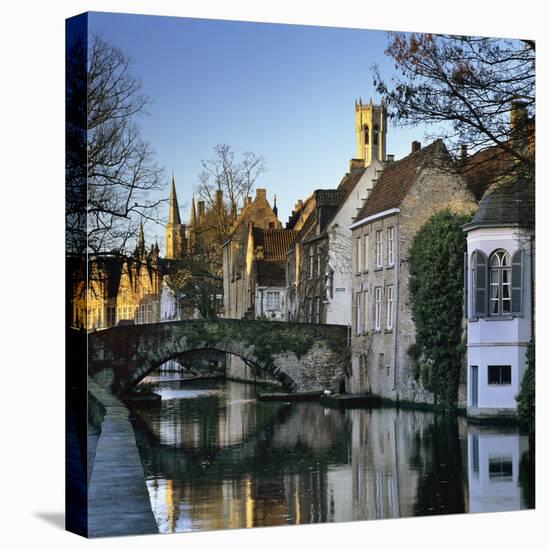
348, 140, 477, 403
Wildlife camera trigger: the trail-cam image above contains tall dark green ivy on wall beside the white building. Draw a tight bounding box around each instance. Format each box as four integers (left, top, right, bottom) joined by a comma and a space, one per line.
408, 210, 470, 409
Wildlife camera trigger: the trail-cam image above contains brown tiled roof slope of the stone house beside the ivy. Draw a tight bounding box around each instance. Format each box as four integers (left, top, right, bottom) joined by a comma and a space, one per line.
356, 139, 452, 221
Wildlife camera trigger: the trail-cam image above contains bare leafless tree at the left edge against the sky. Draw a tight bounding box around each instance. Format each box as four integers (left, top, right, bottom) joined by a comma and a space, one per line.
67, 35, 163, 254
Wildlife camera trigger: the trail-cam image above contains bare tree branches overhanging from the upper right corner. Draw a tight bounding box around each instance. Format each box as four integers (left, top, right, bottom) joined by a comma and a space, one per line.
372, 33, 535, 175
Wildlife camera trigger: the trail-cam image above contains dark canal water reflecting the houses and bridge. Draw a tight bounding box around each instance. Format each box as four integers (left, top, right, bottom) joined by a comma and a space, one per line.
127, 374, 534, 533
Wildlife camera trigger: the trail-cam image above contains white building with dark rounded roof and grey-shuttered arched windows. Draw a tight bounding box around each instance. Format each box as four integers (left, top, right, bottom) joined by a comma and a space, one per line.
464, 178, 534, 419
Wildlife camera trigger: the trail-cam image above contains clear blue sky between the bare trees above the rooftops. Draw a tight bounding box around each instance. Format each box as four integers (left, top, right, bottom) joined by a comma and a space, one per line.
89, 13, 425, 250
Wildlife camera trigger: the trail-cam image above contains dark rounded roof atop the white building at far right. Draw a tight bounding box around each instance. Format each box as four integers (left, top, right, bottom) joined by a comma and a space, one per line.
463, 174, 535, 231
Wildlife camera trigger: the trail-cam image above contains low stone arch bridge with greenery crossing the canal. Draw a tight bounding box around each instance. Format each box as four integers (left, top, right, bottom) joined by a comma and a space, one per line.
88, 319, 350, 394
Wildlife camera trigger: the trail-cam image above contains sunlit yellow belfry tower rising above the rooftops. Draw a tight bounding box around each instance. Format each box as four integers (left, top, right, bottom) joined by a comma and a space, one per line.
355, 98, 387, 166
